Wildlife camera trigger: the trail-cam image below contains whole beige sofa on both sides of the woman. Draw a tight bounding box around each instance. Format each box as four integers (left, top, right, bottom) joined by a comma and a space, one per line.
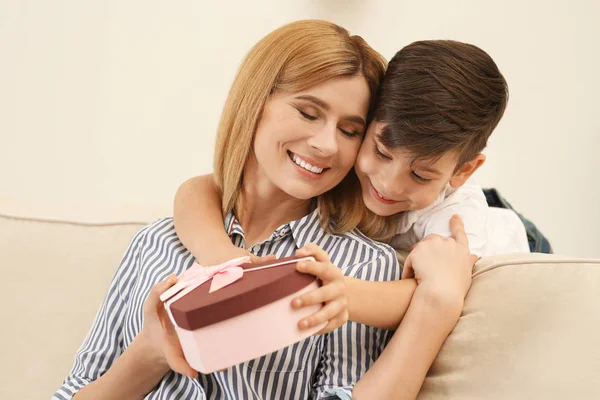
0, 208, 600, 400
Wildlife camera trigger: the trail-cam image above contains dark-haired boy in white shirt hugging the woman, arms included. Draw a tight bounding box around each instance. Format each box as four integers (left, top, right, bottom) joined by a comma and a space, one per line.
175, 41, 528, 330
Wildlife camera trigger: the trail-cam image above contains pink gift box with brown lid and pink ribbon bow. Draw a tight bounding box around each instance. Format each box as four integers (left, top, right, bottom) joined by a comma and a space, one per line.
160, 257, 325, 374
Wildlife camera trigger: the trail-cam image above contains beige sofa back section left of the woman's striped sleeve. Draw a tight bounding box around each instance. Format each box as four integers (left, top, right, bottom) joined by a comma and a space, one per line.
0, 215, 142, 400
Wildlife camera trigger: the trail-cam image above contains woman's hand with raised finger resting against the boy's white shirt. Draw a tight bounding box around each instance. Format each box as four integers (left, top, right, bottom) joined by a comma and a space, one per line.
402, 215, 477, 300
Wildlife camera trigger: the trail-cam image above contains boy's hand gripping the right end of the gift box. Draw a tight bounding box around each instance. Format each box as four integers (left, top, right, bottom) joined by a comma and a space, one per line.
292, 243, 348, 335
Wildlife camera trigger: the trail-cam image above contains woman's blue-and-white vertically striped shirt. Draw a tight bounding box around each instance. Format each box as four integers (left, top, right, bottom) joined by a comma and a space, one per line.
53, 211, 400, 400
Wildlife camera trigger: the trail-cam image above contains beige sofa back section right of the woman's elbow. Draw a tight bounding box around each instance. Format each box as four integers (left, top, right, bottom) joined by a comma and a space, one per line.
418, 254, 600, 400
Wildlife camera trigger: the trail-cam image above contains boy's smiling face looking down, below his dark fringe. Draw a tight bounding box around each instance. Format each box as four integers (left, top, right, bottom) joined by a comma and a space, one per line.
354, 121, 456, 216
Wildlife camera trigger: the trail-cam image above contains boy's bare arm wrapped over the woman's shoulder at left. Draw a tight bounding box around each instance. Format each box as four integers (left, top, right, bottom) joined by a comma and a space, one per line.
173, 174, 250, 265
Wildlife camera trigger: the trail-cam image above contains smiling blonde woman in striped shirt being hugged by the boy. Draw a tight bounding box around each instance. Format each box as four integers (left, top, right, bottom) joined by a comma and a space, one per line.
54, 21, 468, 400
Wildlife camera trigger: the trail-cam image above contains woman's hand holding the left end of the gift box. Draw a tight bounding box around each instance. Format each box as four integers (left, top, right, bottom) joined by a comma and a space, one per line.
140, 275, 198, 378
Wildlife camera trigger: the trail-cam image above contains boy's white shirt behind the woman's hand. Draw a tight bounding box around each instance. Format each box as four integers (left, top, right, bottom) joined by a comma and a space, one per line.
390, 179, 529, 257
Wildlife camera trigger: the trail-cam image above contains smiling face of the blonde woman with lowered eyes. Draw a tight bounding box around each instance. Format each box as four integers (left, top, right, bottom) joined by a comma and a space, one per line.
254, 76, 370, 199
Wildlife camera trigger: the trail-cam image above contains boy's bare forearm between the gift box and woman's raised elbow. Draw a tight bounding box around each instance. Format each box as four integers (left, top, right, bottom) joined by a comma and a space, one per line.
344, 277, 417, 330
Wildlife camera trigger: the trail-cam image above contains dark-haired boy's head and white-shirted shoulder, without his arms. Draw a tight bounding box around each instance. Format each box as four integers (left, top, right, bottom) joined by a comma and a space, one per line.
355, 41, 529, 257
